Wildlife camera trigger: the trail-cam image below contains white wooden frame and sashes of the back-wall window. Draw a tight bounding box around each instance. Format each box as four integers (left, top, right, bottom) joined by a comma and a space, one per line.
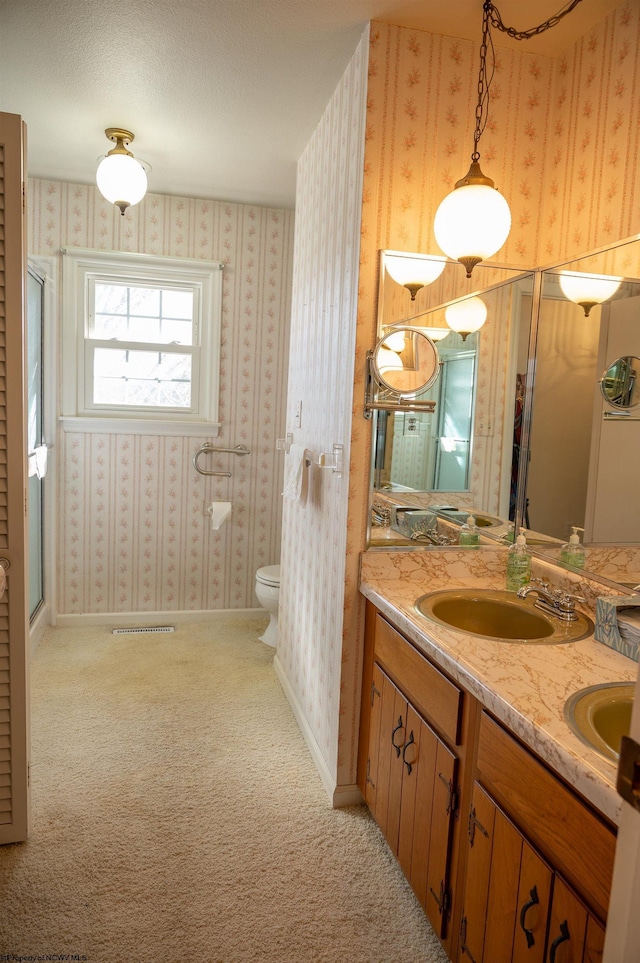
61, 248, 224, 436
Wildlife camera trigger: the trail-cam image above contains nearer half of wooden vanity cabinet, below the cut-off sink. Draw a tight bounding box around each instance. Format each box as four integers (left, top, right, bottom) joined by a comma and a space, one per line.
459, 713, 615, 963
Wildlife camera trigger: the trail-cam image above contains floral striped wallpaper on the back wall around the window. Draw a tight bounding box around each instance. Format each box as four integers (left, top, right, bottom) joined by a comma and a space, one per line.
29, 180, 293, 615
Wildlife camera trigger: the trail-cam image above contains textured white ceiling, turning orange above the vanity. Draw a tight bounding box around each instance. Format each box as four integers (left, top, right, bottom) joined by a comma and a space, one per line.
0, 0, 621, 207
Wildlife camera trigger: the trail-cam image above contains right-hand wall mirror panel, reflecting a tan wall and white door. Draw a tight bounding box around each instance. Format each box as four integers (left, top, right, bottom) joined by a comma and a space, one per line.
520, 239, 640, 588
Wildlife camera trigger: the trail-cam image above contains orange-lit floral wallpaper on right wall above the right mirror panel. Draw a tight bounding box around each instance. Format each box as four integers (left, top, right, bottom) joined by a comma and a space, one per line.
538, 0, 640, 264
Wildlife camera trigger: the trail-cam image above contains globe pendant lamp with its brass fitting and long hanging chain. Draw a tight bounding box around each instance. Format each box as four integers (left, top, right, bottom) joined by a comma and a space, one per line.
433, 0, 582, 278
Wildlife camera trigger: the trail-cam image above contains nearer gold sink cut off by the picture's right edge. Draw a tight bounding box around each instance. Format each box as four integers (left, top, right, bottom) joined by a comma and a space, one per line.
564, 682, 635, 762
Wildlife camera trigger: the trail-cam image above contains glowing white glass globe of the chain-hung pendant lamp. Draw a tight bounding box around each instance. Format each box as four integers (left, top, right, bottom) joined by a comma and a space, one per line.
433, 184, 511, 261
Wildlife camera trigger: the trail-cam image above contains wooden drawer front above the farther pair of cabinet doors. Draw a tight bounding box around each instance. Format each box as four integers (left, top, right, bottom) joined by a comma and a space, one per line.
375, 615, 462, 746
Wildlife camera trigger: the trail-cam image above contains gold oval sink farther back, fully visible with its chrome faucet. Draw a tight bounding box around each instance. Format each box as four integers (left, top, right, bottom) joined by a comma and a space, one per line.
415, 588, 593, 644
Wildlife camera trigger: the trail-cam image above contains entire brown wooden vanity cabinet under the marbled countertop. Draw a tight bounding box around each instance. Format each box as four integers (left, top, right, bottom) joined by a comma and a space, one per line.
358, 602, 616, 963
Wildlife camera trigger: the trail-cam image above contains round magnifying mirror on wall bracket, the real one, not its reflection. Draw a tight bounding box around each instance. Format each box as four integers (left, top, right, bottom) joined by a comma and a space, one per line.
372, 327, 440, 397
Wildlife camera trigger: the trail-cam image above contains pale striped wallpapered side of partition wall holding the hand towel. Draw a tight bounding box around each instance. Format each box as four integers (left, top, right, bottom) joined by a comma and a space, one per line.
277, 37, 367, 785
